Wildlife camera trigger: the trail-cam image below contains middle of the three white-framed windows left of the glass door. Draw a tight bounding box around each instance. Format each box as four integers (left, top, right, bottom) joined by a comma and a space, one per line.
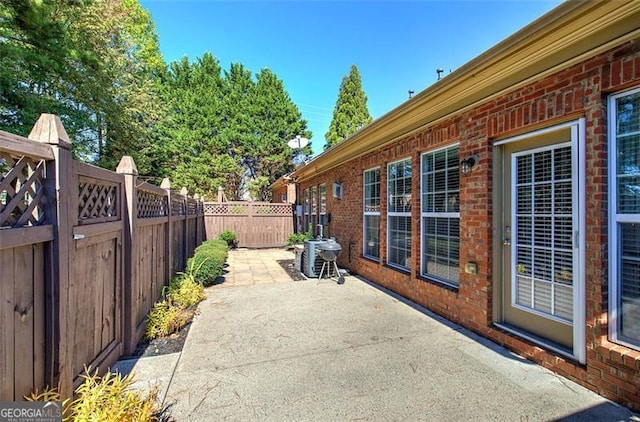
387, 158, 411, 269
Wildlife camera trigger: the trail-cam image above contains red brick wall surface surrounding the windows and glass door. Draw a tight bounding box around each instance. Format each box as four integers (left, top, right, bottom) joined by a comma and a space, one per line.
300, 39, 640, 410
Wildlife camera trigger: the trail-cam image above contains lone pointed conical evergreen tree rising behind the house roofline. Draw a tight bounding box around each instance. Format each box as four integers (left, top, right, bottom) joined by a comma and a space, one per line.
324, 65, 373, 149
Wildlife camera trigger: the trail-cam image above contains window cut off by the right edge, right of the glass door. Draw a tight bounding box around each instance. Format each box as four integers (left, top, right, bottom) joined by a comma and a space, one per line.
609, 89, 640, 348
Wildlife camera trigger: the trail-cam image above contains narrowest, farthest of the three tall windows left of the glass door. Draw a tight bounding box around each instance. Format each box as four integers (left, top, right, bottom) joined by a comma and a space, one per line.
363, 168, 380, 260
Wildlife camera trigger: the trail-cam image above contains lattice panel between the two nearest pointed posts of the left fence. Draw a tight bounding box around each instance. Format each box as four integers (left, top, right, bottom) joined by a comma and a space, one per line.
78, 179, 120, 222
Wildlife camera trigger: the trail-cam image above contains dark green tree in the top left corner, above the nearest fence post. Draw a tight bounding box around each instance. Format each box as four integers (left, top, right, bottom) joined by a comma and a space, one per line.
0, 0, 88, 135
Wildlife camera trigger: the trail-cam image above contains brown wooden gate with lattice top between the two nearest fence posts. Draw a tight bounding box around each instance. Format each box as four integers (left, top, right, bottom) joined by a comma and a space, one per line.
67, 162, 124, 386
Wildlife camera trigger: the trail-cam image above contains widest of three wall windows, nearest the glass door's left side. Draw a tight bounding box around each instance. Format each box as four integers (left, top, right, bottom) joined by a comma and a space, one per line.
421, 146, 460, 286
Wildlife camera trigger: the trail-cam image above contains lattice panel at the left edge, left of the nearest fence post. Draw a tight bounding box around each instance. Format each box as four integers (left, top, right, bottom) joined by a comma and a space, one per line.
0, 153, 46, 228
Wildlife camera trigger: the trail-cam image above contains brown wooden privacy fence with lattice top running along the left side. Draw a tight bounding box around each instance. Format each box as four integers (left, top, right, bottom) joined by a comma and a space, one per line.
0, 115, 204, 401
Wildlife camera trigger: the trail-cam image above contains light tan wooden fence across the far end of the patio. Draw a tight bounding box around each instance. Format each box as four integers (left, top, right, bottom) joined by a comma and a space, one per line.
204, 202, 294, 248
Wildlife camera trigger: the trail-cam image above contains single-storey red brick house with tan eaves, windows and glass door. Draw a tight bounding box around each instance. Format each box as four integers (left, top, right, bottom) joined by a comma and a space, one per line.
291, 1, 640, 410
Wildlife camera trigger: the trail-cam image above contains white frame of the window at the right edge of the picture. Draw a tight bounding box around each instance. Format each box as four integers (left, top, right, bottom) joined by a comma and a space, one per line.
607, 88, 640, 350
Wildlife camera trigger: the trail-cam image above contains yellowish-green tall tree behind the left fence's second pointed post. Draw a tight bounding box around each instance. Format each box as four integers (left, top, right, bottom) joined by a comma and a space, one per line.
76, 0, 165, 175
